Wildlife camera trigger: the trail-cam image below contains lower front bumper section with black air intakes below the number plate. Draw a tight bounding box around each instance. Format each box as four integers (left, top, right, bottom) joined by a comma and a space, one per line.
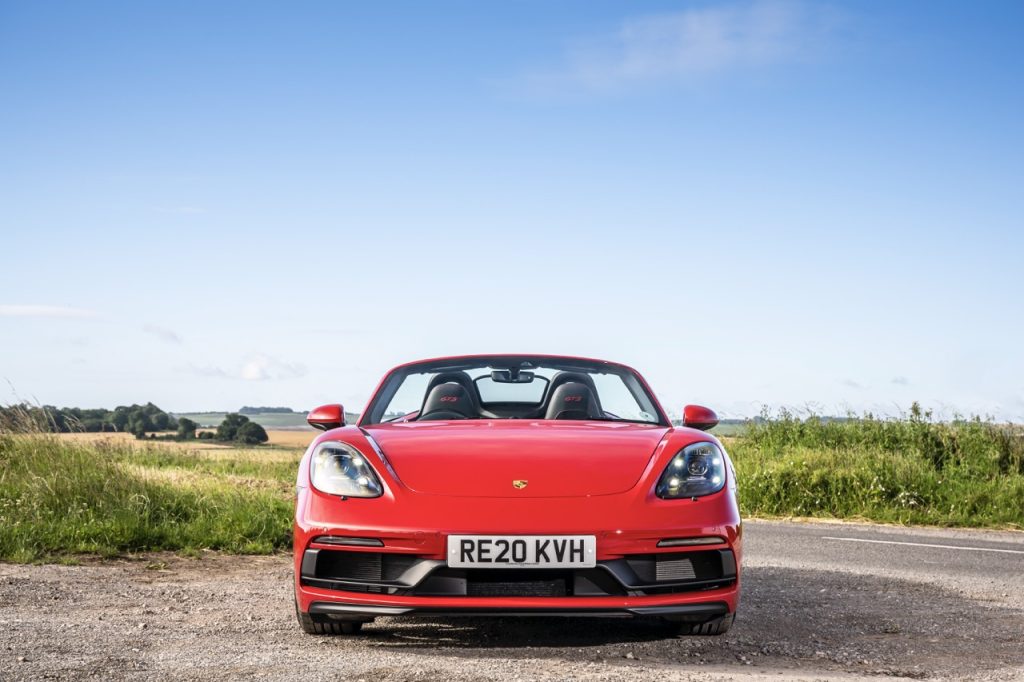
296, 532, 739, 622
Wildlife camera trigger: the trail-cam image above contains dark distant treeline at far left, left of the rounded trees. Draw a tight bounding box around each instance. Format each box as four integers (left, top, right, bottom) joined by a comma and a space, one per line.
0, 402, 178, 436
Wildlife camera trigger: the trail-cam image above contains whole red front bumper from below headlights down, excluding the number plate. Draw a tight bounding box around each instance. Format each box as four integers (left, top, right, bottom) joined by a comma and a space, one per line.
294, 471, 742, 622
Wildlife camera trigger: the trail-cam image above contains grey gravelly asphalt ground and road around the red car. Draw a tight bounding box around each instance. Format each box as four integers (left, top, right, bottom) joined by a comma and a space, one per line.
0, 521, 1024, 681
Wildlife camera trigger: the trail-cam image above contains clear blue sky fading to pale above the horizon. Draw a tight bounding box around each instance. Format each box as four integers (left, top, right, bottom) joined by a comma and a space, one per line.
0, 0, 1024, 421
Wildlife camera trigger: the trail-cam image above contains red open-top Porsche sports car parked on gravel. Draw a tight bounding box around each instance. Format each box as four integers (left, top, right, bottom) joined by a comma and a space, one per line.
295, 355, 741, 635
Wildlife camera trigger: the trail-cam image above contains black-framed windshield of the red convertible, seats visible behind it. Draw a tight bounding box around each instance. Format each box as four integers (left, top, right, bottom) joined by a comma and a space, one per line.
364, 357, 662, 424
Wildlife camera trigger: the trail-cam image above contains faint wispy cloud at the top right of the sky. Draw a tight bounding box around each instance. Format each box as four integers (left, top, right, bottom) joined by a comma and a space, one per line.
526, 0, 839, 93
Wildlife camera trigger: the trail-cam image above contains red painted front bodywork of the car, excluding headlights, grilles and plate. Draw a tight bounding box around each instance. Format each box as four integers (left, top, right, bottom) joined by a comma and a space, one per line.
294, 356, 742, 610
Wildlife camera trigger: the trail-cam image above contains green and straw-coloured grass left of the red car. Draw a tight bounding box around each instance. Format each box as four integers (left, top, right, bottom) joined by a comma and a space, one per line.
0, 434, 301, 561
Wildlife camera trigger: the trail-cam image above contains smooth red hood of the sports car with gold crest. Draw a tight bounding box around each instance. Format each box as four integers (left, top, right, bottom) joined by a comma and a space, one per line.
365, 420, 668, 498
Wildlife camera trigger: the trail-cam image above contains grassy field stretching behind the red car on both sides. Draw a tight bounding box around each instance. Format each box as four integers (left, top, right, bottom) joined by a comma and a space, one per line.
0, 414, 1024, 561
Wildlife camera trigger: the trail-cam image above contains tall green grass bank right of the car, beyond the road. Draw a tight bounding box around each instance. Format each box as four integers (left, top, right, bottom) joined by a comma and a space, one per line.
730, 404, 1024, 528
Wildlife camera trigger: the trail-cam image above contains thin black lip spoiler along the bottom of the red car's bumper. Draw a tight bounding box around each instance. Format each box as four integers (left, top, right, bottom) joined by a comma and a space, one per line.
309, 601, 729, 622
